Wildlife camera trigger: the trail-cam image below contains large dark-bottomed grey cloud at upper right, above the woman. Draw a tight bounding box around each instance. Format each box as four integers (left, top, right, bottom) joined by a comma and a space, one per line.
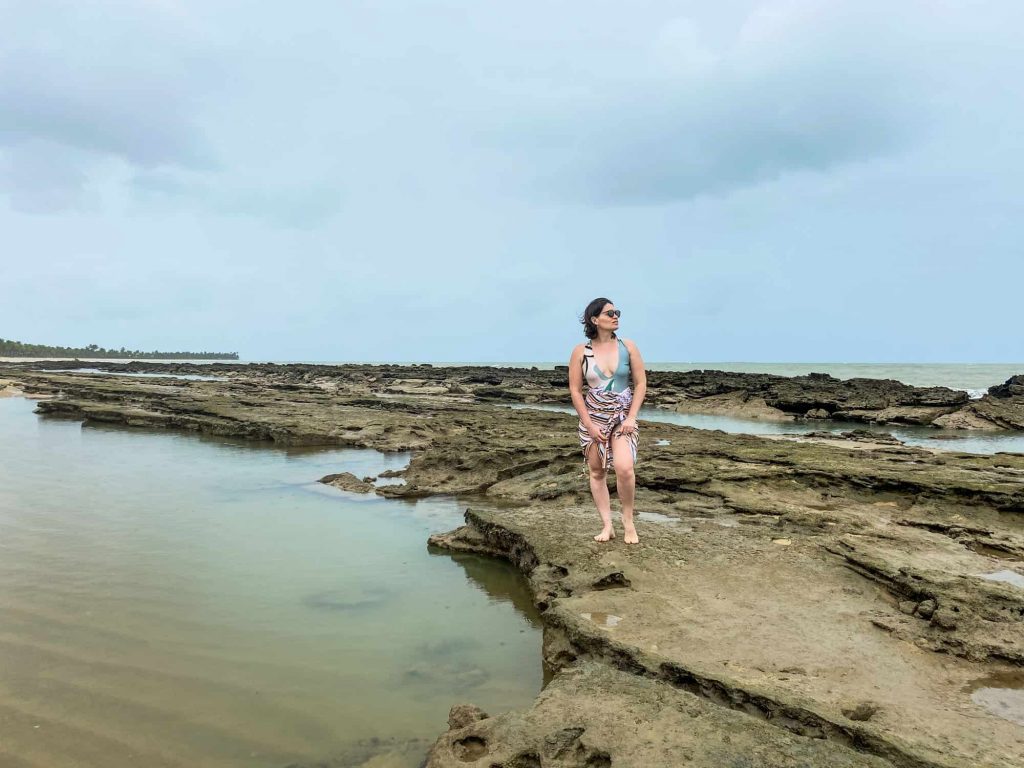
496, 0, 938, 205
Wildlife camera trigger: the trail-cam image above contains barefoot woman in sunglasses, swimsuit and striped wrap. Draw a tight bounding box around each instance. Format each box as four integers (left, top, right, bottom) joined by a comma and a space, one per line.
569, 298, 647, 544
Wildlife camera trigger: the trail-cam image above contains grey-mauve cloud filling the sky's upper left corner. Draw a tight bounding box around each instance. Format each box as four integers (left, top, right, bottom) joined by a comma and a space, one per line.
0, 0, 217, 214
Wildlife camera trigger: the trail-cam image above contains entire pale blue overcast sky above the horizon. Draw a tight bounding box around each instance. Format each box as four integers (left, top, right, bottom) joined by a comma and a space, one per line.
0, 0, 1024, 362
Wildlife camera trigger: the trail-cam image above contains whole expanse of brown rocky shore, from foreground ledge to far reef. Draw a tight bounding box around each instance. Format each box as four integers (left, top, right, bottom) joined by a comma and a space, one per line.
0, 362, 1024, 768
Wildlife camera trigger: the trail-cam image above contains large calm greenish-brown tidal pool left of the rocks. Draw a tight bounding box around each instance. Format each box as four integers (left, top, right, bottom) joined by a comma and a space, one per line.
0, 398, 542, 768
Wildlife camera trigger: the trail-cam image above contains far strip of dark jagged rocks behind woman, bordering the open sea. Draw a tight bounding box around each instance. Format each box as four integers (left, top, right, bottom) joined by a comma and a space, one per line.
12, 360, 1024, 430
